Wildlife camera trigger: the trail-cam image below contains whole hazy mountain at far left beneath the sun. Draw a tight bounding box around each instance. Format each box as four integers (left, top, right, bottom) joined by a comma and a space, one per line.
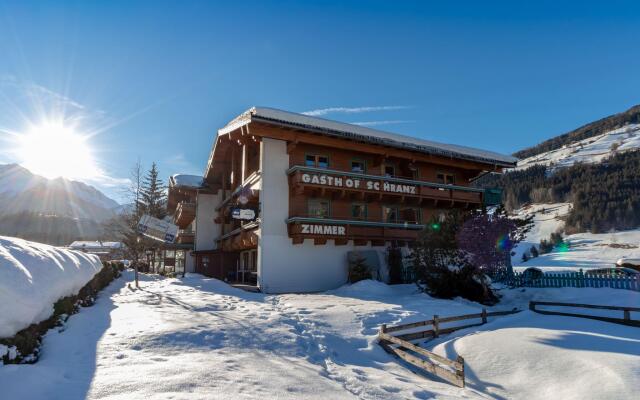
0, 164, 120, 245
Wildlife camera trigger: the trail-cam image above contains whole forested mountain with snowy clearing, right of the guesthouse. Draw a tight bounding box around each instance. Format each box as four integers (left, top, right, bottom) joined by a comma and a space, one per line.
475, 106, 640, 233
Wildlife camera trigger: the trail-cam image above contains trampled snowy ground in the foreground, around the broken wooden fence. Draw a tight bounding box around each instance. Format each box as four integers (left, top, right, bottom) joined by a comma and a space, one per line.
0, 272, 640, 400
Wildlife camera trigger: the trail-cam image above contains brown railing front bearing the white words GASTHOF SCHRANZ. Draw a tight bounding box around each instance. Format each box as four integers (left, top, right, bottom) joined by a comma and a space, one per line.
287, 165, 484, 204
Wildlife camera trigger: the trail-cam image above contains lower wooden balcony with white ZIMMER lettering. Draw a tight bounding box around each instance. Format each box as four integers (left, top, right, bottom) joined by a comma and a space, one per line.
286, 216, 425, 246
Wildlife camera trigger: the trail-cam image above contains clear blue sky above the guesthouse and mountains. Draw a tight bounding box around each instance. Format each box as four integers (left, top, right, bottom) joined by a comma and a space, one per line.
0, 0, 640, 203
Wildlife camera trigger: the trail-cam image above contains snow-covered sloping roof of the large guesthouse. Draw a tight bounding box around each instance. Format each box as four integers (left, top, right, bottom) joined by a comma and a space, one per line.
220, 107, 517, 167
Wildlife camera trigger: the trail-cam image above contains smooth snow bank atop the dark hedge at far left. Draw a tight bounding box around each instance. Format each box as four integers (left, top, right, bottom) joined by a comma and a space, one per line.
0, 236, 102, 338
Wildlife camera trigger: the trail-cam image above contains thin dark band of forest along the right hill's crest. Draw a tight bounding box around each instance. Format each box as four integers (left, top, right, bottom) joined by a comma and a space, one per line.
513, 105, 640, 159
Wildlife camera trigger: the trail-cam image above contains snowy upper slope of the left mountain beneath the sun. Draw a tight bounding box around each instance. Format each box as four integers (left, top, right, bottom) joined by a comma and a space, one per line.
0, 164, 119, 221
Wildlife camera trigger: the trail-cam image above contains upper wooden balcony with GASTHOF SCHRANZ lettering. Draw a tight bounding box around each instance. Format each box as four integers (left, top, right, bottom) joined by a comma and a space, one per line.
287, 165, 484, 207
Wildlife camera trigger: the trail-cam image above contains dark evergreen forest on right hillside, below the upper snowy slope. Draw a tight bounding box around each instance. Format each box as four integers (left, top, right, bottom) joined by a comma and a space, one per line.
475, 151, 640, 233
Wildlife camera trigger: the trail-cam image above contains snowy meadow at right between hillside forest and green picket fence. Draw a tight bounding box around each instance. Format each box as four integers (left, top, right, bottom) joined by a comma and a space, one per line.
511, 203, 640, 272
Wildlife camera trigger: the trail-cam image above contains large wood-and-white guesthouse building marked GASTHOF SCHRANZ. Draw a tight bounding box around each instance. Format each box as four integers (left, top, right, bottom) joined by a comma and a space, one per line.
168, 108, 516, 293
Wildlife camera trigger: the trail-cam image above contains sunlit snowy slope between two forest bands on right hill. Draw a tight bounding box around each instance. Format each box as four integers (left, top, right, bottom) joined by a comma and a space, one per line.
516, 124, 640, 169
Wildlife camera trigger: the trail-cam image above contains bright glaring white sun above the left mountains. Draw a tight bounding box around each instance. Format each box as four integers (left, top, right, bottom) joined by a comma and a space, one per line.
15, 121, 99, 179
